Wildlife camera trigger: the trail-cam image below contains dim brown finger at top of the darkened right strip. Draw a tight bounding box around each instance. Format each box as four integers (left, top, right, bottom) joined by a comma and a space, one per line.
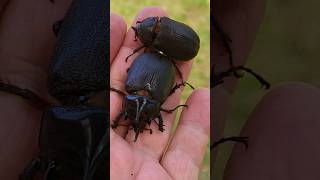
212, 0, 266, 92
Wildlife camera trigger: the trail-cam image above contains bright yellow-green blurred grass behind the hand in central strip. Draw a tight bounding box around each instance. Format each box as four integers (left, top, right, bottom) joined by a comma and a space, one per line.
110, 0, 210, 180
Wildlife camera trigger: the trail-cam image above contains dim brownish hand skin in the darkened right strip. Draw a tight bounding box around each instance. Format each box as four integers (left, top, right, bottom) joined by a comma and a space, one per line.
211, 0, 320, 180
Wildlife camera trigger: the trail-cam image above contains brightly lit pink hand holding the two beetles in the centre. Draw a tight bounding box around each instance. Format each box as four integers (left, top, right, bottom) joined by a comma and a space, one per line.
110, 7, 210, 180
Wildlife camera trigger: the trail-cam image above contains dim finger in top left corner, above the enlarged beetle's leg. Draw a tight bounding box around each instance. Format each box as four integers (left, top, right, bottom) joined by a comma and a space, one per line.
0, 0, 71, 102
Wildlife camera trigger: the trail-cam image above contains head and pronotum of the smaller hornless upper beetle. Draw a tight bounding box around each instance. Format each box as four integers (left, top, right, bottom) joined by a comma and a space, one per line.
132, 17, 159, 46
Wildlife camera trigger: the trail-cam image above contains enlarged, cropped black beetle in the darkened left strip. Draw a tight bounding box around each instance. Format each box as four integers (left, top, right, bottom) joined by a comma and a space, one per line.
16, 0, 109, 180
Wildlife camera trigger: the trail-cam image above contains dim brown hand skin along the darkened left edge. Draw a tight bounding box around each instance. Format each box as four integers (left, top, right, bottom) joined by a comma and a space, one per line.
0, 0, 71, 180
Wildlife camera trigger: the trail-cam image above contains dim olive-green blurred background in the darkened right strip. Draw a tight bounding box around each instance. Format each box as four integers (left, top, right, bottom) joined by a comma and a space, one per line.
213, 0, 320, 180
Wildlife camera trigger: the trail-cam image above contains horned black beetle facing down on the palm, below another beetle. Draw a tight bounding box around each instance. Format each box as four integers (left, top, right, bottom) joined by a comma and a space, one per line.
111, 53, 186, 141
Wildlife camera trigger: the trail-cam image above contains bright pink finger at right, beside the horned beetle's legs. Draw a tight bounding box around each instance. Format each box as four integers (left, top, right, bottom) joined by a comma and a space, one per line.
161, 89, 210, 179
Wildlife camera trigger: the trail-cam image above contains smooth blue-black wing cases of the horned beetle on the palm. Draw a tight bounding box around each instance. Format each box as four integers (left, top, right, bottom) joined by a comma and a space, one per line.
126, 53, 176, 104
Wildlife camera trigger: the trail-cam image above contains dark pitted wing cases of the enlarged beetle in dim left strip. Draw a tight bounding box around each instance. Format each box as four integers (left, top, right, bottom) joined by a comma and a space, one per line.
48, 0, 109, 101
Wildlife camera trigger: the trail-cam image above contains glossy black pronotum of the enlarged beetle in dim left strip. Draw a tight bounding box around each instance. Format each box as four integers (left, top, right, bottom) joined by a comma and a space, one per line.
39, 106, 109, 180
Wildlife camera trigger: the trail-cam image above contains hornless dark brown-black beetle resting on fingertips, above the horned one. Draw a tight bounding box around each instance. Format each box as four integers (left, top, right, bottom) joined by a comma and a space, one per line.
126, 17, 200, 61
